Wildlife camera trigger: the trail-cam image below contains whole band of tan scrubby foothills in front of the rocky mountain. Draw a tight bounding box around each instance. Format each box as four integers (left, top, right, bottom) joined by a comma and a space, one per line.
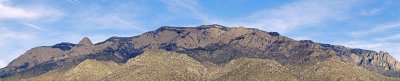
3, 49, 399, 81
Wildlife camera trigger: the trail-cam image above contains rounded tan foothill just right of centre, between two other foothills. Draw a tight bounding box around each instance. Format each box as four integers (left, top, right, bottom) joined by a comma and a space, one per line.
209, 58, 297, 81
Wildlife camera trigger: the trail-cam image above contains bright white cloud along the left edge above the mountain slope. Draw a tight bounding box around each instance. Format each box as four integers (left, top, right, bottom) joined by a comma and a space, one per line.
0, 0, 64, 67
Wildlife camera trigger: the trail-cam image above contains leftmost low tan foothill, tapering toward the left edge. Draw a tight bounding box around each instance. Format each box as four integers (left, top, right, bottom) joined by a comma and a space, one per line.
8, 59, 119, 81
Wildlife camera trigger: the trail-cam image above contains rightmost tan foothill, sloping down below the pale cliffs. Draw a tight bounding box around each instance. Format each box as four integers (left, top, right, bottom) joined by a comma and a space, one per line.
299, 59, 392, 81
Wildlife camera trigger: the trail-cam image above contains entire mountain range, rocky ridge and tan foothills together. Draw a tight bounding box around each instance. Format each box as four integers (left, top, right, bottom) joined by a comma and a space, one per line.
0, 24, 400, 81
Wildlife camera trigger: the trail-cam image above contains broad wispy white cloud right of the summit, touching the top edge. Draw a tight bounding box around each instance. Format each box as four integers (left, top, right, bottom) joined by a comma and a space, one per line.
245, 0, 358, 32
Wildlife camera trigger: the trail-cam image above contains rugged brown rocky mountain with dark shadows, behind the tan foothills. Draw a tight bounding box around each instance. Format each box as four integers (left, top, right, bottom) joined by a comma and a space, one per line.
0, 25, 400, 77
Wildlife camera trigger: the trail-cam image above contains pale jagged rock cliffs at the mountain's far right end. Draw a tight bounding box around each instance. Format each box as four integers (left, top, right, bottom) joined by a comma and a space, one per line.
322, 44, 400, 73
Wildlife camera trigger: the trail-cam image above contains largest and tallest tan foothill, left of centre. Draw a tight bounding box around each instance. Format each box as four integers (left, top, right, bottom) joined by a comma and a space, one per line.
104, 51, 206, 81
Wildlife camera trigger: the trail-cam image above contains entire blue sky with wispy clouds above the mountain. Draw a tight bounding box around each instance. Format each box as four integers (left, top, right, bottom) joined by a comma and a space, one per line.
0, 0, 400, 67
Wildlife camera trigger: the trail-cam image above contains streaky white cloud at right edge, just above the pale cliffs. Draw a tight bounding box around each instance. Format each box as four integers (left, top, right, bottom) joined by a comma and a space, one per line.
337, 22, 400, 60
